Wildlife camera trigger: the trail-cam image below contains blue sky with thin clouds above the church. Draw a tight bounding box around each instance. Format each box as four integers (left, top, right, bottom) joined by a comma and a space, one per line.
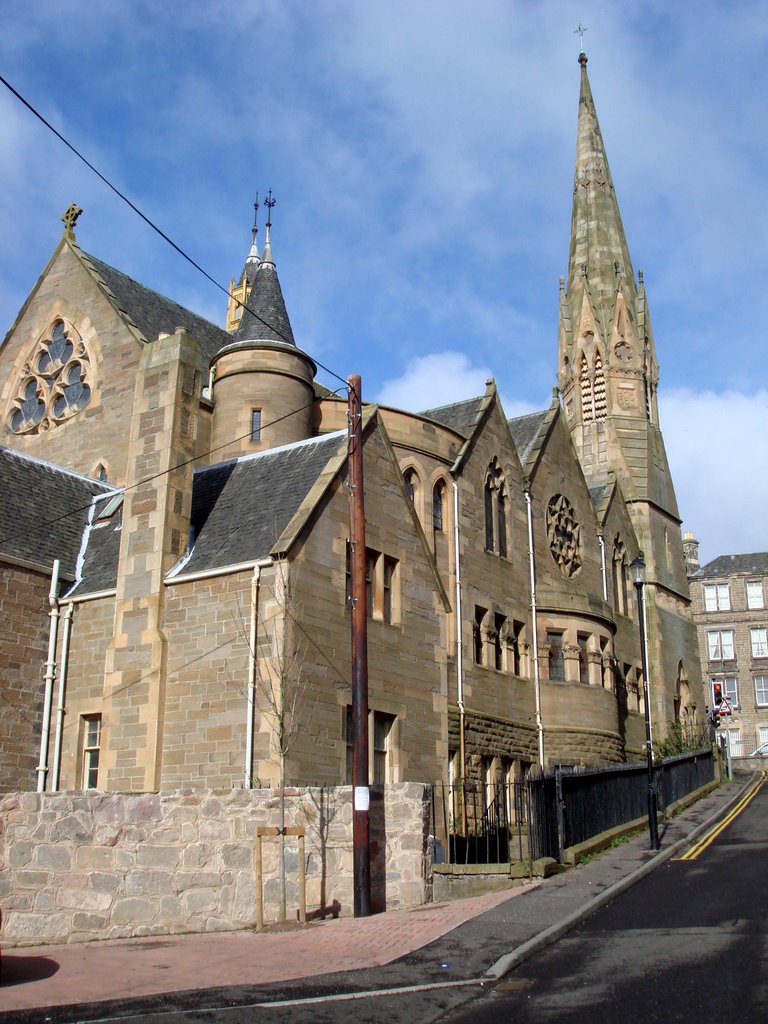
0, 0, 768, 560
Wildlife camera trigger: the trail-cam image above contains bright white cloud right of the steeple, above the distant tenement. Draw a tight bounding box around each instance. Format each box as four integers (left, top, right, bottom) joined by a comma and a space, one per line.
659, 388, 768, 564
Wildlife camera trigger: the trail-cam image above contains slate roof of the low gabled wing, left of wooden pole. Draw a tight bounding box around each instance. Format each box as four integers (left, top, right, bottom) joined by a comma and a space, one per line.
173, 430, 346, 575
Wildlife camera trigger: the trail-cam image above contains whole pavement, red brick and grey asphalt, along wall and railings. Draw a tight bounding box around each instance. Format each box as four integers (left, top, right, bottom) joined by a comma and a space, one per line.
0, 775, 754, 1024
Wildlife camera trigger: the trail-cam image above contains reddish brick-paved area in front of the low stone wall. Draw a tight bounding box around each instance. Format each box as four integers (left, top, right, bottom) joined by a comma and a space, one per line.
0, 883, 538, 1013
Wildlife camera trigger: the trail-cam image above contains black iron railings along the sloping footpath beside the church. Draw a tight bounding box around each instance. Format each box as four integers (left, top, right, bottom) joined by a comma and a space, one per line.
432, 750, 715, 864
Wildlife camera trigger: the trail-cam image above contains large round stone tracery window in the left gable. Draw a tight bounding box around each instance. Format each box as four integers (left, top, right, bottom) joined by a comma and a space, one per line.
7, 319, 92, 434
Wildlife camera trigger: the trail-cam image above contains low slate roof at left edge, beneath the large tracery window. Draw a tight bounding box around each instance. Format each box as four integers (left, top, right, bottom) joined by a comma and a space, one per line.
0, 445, 113, 580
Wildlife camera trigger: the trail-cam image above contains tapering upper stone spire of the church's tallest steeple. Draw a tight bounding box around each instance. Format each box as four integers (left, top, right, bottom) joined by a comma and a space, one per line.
567, 52, 635, 330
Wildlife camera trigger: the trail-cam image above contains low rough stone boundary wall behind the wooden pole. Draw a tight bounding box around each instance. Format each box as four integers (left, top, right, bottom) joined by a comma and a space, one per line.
0, 783, 430, 947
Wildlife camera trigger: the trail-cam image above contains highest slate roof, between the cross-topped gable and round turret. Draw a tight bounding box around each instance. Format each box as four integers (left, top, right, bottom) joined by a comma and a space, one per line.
81, 251, 232, 361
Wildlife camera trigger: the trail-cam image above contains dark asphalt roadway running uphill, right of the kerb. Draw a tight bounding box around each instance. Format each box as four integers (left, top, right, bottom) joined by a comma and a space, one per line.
443, 784, 768, 1024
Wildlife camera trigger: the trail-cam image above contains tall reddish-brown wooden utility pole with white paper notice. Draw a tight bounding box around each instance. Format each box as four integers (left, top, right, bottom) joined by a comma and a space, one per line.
347, 374, 371, 918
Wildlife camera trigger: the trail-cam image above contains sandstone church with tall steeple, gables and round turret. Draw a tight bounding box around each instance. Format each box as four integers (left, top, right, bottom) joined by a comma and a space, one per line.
0, 54, 705, 792
